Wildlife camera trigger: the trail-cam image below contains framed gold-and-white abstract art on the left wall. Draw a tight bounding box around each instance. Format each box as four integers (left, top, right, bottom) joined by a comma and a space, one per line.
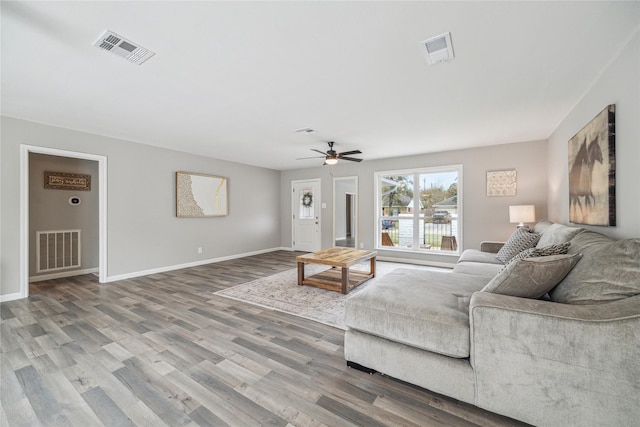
176, 172, 228, 218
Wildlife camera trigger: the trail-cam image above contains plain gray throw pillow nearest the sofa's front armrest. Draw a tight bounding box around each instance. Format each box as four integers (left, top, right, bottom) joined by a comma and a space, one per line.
482, 254, 582, 298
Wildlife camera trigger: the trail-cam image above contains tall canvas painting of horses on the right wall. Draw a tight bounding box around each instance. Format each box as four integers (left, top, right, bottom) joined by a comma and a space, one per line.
568, 104, 616, 226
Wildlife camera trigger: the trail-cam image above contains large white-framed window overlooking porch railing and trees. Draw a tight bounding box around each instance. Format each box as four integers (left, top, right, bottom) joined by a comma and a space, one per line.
376, 165, 462, 254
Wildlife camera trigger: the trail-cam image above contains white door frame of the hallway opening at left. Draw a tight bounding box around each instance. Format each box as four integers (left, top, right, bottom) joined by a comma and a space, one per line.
20, 144, 107, 298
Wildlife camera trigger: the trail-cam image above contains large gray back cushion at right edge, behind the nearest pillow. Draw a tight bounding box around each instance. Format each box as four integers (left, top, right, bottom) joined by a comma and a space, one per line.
549, 239, 640, 304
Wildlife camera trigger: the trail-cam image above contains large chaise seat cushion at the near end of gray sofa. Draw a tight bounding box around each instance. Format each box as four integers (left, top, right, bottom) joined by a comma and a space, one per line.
344, 268, 490, 358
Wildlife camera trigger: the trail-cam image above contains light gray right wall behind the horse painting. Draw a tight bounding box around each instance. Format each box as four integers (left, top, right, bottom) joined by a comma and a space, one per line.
548, 31, 640, 238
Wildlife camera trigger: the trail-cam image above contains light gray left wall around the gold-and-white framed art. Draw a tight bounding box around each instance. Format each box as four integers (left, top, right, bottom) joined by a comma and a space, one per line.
0, 117, 281, 295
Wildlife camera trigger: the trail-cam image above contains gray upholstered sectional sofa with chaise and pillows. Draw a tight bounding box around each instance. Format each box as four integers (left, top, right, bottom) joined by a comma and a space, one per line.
344, 221, 640, 426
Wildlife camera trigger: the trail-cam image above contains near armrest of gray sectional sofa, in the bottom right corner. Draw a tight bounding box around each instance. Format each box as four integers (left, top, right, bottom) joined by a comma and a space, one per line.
469, 292, 640, 425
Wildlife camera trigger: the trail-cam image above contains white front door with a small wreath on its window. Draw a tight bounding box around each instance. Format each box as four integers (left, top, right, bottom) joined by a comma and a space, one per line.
291, 179, 321, 252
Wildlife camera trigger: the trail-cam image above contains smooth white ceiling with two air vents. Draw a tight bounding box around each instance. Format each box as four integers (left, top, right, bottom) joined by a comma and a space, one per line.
1, 1, 640, 170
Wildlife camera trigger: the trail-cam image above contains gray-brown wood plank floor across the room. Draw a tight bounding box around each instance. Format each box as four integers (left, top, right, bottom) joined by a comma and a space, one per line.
0, 251, 519, 427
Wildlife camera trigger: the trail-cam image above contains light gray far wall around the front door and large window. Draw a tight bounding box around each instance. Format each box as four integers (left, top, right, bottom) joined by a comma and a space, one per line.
280, 141, 547, 263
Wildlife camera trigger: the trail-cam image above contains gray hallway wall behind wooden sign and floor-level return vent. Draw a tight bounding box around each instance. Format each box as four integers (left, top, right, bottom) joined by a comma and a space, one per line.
29, 153, 100, 276
